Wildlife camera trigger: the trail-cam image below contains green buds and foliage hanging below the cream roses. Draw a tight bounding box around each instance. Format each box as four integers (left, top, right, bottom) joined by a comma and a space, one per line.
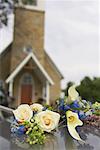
24, 119, 46, 145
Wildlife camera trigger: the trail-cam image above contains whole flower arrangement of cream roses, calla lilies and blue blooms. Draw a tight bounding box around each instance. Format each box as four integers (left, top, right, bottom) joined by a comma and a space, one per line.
11, 86, 99, 145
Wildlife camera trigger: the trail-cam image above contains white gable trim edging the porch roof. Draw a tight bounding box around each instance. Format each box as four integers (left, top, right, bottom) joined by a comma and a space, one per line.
6, 52, 54, 85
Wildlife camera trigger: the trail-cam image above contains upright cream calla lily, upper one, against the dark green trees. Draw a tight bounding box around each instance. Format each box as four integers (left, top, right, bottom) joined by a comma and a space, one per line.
67, 85, 79, 104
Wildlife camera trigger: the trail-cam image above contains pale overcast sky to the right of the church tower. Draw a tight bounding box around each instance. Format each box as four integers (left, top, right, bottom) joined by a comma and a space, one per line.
45, 0, 100, 85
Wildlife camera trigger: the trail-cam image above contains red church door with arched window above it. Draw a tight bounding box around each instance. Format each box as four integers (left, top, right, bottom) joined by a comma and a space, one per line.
20, 73, 34, 104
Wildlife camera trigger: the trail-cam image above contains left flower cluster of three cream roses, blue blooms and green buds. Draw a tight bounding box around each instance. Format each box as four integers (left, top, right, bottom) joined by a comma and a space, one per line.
11, 103, 60, 145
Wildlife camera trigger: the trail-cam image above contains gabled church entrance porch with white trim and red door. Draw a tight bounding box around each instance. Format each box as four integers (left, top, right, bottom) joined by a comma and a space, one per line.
6, 53, 54, 106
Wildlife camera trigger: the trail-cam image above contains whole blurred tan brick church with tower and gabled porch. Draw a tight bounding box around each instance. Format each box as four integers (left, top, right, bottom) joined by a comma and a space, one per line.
0, 0, 63, 107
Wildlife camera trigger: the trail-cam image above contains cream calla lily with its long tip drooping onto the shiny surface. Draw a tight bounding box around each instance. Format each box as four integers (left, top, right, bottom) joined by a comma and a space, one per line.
66, 110, 83, 141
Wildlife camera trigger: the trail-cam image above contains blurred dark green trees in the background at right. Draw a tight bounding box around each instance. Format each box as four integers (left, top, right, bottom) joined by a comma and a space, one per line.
65, 76, 100, 103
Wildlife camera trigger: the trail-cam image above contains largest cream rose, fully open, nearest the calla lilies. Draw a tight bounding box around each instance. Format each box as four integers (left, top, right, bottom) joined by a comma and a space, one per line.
35, 110, 60, 132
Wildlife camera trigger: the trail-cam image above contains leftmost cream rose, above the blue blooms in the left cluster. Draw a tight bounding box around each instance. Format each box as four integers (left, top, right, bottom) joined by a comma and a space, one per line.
13, 104, 33, 122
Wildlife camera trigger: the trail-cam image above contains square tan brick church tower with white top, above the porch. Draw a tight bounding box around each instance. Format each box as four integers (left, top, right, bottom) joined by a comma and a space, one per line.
11, 0, 45, 71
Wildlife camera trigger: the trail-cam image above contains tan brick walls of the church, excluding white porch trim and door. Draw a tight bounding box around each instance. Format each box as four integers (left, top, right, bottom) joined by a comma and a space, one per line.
0, 8, 63, 107
